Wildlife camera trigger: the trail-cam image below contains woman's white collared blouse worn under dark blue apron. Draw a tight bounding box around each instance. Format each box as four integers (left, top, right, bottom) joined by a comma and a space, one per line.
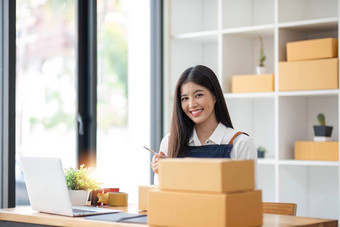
154, 123, 257, 185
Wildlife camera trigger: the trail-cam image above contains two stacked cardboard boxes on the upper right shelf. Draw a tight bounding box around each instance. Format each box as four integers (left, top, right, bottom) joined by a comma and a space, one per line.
279, 38, 339, 91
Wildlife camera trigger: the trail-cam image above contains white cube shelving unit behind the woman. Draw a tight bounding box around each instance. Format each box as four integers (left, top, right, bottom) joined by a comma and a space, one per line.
164, 0, 340, 219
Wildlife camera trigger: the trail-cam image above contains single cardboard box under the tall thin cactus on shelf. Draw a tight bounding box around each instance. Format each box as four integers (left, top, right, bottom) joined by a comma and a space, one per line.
231, 74, 274, 93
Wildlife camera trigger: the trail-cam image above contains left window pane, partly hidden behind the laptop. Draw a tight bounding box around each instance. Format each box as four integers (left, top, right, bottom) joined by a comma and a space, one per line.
16, 0, 76, 205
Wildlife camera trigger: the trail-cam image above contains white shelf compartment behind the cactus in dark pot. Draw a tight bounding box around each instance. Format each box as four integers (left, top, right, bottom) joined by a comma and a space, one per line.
278, 96, 339, 160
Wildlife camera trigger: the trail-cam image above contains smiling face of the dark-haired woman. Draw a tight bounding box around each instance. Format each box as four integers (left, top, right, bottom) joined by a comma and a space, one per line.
181, 82, 217, 125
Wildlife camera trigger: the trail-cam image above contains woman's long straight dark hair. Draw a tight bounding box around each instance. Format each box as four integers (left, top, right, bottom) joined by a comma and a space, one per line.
168, 65, 233, 158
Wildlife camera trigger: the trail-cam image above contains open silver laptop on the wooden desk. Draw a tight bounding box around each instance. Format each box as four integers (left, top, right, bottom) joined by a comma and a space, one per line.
21, 157, 121, 217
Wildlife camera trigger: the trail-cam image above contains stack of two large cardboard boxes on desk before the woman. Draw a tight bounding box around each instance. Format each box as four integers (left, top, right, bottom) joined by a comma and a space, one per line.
148, 158, 262, 227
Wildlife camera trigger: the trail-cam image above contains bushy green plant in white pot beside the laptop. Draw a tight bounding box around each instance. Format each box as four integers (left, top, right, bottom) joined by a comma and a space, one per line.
65, 165, 102, 206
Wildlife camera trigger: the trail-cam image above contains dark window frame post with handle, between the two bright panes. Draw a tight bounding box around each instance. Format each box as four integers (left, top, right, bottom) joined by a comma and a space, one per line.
76, 0, 97, 167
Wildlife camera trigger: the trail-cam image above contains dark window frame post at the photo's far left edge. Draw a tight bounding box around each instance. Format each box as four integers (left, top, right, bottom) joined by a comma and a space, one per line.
0, 0, 16, 208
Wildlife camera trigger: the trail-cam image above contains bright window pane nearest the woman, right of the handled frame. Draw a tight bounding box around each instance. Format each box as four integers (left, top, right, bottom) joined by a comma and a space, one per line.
97, 0, 150, 202
